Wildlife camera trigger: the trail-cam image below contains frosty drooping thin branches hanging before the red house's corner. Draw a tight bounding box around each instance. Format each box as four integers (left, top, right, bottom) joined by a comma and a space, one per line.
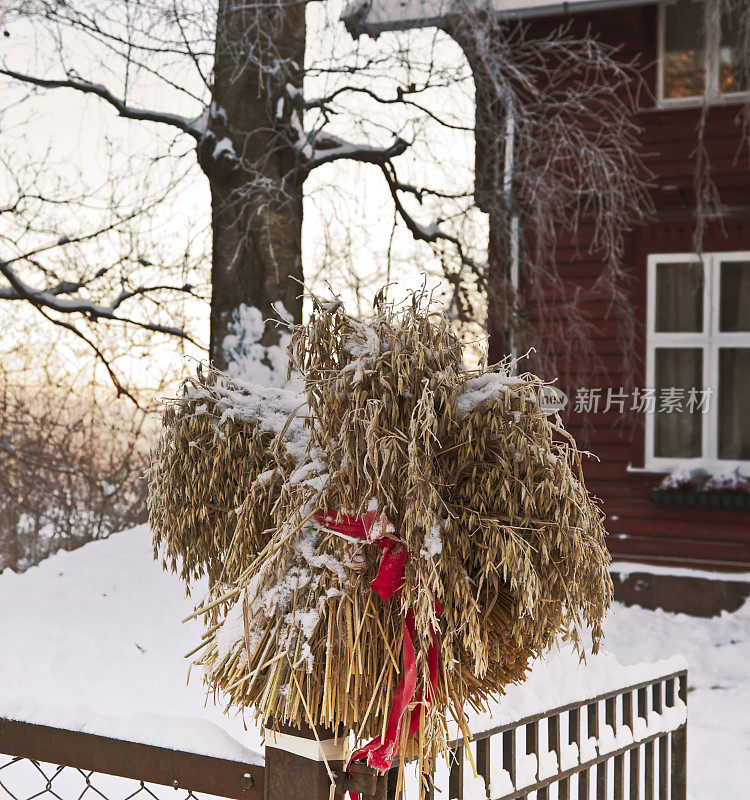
446, 16, 652, 388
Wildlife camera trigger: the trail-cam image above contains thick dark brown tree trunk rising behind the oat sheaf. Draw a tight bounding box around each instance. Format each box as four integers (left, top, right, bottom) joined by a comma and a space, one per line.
199, 0, 305, 369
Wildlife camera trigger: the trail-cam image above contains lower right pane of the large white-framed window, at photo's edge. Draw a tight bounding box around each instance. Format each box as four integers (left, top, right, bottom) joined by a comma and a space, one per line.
719, 347, 750, 461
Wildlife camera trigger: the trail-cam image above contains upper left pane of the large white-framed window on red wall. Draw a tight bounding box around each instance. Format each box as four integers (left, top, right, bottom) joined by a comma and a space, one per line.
654, 261, 703, 333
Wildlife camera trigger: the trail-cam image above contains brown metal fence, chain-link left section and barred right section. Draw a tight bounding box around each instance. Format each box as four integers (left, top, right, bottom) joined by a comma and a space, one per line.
0, 671, 687, 800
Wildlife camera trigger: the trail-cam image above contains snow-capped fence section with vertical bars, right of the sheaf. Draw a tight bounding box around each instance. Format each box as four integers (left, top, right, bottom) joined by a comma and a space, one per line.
440, 671, 687, 800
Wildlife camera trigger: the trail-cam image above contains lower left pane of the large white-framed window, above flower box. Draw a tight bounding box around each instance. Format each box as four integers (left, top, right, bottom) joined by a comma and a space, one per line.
654, 347, 703, 458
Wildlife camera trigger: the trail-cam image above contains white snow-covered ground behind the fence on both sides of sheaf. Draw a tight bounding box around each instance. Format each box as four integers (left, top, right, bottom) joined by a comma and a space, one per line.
0, 526, 750, 800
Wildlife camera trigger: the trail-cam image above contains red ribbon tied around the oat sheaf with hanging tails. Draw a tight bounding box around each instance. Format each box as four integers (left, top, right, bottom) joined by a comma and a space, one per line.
315, 511, 442, 784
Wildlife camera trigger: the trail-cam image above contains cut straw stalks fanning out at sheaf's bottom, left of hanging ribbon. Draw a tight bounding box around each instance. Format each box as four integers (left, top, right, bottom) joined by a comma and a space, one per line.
201, 484, 414, 748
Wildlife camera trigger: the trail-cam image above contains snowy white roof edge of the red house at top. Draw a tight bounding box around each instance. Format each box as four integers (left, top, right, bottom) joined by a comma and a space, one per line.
342, 0, 655, 36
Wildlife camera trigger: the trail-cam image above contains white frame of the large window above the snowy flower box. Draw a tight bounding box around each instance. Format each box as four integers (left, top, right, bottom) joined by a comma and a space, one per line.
644, 250, 750, 475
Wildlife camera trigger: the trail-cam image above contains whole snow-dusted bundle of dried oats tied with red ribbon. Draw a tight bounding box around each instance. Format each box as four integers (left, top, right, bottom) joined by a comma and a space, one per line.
150, 303, 611, 788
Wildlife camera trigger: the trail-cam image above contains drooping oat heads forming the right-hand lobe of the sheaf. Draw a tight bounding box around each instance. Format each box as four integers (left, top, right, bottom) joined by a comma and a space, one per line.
441, 375, 612, 692
